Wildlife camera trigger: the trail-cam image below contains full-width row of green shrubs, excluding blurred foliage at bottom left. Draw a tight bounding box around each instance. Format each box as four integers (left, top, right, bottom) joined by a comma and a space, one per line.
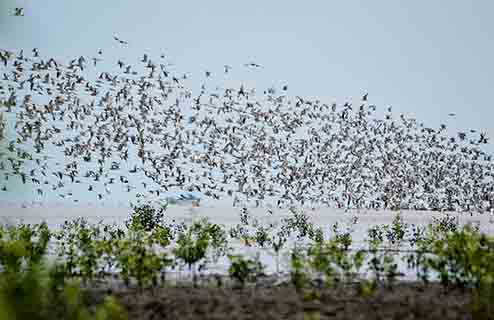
0, 205, 494, 316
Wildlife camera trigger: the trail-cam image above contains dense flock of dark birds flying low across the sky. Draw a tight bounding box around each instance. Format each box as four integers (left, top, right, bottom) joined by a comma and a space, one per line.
0, 35, 494, 211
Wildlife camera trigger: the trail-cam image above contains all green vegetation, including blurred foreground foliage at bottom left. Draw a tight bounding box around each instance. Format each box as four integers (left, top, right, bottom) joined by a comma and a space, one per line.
0, 205, 494, 320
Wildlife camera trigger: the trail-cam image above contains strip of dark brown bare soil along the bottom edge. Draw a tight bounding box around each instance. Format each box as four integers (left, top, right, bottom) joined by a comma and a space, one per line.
87, 283, 488, 320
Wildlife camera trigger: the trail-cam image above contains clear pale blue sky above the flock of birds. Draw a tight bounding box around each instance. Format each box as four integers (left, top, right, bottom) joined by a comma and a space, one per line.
0, 0, 494, 205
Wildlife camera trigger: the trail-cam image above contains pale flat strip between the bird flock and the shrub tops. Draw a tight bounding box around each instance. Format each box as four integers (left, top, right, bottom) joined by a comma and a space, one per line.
0, 204, 494, 234
